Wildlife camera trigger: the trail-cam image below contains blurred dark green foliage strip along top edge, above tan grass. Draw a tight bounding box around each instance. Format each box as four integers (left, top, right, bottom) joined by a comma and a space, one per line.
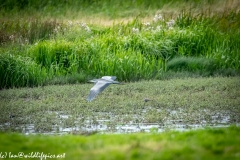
0, 0, 214, 15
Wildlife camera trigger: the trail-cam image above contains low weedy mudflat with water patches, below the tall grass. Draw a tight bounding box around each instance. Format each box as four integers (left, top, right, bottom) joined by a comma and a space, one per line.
0, 77, 240, 134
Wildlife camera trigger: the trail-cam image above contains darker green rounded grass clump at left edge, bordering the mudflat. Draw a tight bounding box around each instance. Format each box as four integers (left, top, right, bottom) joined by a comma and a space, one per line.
0, 54, 46, 89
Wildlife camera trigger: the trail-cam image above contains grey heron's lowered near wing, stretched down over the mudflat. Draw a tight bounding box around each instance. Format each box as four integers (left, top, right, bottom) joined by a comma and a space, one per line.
87, 80, 111, 101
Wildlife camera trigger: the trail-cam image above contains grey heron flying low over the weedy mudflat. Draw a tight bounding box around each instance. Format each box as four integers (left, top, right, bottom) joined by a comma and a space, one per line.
87, 76, 119, 102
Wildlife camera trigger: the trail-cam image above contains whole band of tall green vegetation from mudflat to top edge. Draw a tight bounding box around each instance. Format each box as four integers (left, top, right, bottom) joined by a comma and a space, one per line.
0, 0, 240, 88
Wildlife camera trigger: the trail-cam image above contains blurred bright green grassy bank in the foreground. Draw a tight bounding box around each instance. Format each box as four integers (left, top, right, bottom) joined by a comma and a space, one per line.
0, 127, 240, 160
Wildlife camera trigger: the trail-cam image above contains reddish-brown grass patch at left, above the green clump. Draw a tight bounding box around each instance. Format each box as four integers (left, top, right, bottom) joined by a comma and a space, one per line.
0, 18, 59, 46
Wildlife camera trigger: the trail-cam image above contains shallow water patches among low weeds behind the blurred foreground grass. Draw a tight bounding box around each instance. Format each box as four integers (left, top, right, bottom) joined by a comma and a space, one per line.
0, 109, 239, 135
